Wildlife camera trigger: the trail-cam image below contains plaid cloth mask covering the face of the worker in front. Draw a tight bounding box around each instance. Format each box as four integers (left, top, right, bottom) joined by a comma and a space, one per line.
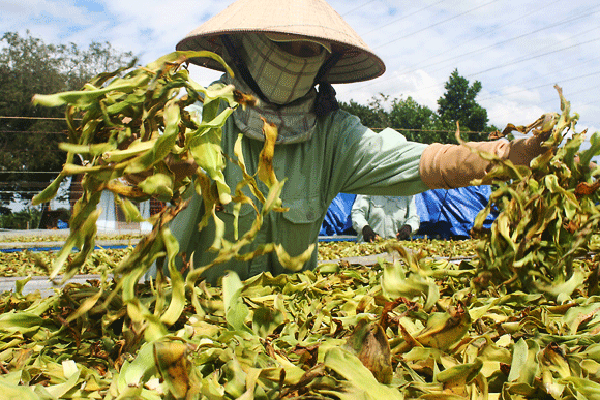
242, 34, 327, 104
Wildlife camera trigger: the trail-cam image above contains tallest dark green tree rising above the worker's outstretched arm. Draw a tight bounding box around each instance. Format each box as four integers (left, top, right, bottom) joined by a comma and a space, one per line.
438, 69, 489, 141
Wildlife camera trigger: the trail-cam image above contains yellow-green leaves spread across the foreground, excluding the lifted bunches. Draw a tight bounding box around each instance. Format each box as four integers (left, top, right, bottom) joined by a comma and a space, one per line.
0, 245, 600, 399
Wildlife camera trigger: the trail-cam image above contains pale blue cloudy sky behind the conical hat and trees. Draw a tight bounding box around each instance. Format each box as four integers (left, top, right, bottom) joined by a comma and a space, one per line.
0, 0, 600, 132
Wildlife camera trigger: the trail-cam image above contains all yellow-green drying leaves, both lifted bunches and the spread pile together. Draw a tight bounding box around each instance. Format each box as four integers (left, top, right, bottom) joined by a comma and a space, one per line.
0, 53, 600, 400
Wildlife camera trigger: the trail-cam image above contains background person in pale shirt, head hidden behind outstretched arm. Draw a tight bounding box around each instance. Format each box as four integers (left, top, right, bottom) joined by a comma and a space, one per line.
350, 195, 420, 242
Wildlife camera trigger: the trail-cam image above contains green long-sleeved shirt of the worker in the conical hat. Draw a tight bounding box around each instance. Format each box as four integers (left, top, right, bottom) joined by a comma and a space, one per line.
171, 111, 428, 282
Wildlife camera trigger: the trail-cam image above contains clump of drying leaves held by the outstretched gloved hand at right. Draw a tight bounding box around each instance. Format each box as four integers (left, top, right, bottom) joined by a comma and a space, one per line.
475, 88, 600, 296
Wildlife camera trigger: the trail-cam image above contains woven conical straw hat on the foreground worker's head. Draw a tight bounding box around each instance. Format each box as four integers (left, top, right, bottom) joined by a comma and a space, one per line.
177, 0, 385, 83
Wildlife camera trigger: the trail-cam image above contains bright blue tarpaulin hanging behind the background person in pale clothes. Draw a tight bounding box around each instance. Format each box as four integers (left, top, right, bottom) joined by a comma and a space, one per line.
319, 186, 497, 239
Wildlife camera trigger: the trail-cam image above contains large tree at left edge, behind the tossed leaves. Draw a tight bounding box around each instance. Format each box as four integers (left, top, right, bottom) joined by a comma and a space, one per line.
0, 32, 134, 203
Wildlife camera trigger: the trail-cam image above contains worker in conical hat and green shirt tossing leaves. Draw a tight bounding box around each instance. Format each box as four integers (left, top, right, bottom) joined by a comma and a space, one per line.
166, 0, 546, 283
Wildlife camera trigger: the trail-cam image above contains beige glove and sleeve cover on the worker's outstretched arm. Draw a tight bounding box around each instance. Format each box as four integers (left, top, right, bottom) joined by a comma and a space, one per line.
419, 135, 548, 189
